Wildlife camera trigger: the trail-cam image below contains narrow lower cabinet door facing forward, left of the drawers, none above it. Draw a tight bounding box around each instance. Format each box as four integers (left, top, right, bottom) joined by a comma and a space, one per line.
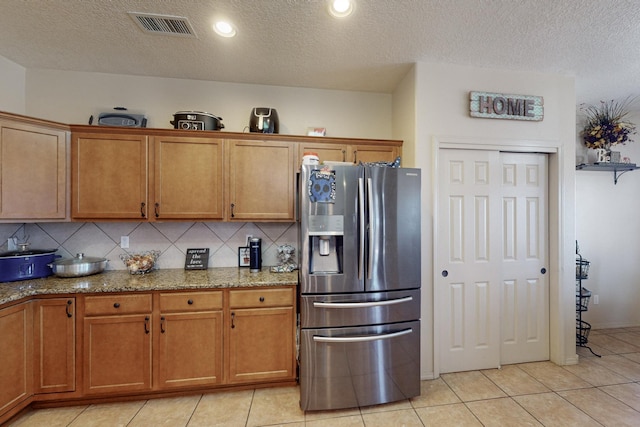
33, 298, 76, 394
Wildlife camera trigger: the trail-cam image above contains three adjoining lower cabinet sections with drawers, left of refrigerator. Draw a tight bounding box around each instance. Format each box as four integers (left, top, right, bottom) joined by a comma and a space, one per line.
77, 286, 296, 395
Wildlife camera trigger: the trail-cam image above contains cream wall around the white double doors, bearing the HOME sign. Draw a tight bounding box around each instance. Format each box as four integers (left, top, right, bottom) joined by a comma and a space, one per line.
402, 63, 577, 378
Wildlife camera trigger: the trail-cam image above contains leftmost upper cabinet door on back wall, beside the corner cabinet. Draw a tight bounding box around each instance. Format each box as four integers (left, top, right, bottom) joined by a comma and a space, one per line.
71, 133, 148, 220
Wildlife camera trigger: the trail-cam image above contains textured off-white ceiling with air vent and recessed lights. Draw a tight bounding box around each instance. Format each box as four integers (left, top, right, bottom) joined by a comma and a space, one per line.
0, 0, 640, 108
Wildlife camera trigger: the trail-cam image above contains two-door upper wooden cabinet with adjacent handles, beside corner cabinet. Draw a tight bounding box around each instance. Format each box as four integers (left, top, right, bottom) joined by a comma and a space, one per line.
71, 133, 223, 220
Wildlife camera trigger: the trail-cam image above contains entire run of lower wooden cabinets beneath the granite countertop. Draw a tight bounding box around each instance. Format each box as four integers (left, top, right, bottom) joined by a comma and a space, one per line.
0, 285, 296, 424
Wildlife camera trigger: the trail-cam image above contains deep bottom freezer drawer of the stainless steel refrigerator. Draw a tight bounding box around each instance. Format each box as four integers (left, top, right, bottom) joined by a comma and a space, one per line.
300, 320, 420, 411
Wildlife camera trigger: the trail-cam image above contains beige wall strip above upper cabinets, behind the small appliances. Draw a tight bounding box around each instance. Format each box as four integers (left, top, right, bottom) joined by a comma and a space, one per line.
26, 69, 392, 139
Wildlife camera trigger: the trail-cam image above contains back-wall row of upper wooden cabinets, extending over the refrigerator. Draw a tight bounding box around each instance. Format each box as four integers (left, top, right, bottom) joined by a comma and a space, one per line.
71, 125, 402, 222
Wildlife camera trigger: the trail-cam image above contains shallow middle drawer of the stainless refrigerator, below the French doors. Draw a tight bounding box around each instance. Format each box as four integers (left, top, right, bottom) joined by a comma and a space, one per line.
300, 289, 420, 328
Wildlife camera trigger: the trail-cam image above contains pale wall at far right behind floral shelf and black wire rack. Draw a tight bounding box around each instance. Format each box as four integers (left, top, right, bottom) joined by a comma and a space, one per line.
576, 113, 640, 329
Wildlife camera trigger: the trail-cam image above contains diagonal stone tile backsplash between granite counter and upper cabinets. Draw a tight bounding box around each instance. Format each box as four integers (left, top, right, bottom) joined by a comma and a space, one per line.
0, 222, 298, 270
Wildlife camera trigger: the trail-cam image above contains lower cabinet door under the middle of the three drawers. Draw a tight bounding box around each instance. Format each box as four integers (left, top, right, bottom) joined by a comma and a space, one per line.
158, 311, 222, 388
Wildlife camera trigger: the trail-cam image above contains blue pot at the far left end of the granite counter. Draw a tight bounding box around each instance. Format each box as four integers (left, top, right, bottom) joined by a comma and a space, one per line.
0, 249, 60, 282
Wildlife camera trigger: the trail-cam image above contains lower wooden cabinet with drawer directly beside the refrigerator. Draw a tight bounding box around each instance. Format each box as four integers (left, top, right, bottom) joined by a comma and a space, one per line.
229, 288, 295, 383
